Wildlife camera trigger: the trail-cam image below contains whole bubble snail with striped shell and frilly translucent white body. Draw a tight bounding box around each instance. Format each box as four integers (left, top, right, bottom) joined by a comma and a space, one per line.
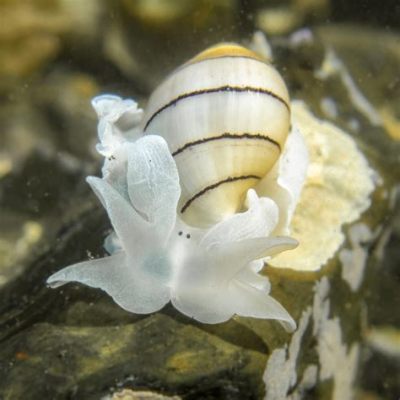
47, 44, 308, 331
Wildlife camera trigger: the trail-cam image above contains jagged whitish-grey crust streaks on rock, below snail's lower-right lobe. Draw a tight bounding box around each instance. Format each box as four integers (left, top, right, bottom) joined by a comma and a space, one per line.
263, 277, 360, 400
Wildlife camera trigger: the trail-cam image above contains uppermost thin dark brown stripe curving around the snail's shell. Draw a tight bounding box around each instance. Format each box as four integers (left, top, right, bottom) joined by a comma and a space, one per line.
144, 85, 290, 130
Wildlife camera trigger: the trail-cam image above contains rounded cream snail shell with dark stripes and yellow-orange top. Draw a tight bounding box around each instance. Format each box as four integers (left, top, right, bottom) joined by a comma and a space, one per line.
143, 44, 290, 226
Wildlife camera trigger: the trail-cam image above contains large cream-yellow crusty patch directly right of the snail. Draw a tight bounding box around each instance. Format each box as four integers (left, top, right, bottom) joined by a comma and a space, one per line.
270, 102, 374, 271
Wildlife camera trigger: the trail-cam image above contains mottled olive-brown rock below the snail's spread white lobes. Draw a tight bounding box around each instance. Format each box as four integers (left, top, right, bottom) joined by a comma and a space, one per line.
0, 314, 266, 399
